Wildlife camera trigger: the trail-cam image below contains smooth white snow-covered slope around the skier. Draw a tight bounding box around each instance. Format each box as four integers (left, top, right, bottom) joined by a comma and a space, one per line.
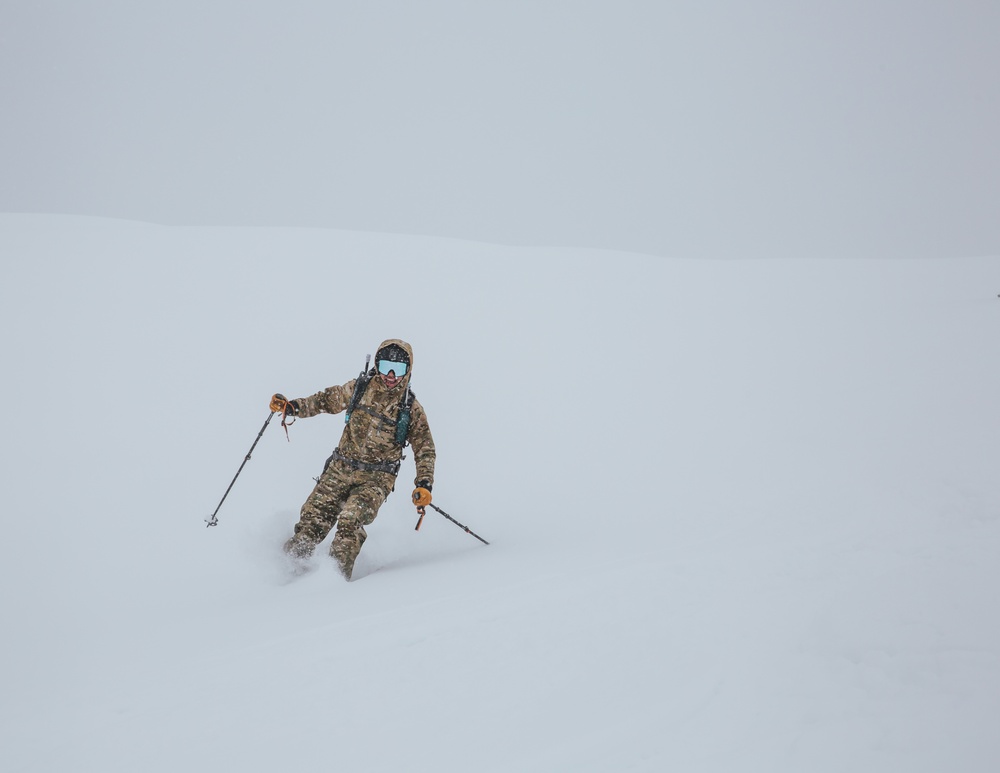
0, 215, 1000, 773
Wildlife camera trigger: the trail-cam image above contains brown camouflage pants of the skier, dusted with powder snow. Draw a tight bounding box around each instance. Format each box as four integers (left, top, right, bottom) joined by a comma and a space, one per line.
285, 462, 396, 580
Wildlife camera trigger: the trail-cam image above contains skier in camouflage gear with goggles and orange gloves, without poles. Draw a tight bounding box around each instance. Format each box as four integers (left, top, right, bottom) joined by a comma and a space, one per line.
270, 339, 436, 580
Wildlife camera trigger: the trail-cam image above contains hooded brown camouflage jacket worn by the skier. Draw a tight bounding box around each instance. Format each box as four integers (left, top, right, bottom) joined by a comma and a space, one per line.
294, 340, 437, 484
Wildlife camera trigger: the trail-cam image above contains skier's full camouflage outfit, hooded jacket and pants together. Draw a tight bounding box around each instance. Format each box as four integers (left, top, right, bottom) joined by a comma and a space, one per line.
285, 339, 437, 579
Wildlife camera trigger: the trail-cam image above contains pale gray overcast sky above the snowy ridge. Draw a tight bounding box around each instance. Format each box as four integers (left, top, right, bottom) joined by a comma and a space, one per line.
0, 0, 1000, 257
